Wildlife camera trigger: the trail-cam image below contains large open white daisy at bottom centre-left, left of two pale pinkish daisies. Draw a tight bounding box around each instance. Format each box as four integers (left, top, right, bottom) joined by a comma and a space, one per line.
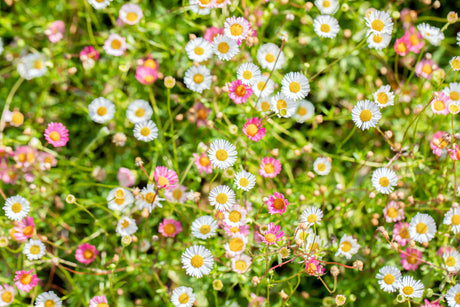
181, 245, 214, 278
